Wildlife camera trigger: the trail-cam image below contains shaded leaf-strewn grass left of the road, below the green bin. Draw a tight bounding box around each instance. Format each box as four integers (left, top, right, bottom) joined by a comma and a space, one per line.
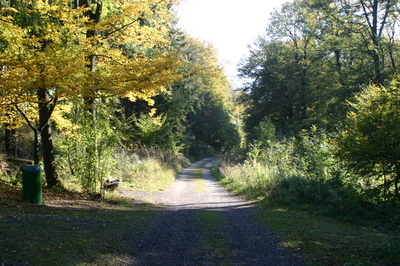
0, 180, 157, 265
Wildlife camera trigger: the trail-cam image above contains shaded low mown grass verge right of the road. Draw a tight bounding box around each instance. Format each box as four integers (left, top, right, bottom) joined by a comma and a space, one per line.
213, 165, 400, 265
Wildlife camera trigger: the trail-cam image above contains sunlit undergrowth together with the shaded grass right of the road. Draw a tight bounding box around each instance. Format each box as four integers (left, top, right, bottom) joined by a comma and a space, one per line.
214, 128, 400, 265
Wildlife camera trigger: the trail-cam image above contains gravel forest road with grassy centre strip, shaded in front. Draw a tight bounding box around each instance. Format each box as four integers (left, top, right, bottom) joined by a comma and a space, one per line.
126, 158, 303, 265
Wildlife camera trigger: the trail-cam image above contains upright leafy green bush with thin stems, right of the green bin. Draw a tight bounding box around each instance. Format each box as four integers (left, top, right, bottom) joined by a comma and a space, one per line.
58, 104, 120, 194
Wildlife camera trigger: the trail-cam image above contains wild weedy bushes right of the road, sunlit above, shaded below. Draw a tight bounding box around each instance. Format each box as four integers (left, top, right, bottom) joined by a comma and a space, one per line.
217, 128, 400, 229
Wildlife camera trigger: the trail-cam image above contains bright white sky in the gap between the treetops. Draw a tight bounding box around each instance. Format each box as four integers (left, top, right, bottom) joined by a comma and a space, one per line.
178, 0, 287, 85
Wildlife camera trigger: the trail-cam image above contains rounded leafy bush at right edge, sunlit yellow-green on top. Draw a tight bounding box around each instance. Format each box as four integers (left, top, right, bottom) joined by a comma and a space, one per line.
337, 83, 400, 201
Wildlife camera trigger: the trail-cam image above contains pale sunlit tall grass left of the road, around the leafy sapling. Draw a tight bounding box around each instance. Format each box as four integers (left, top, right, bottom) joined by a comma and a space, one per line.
54, 148, 189, 193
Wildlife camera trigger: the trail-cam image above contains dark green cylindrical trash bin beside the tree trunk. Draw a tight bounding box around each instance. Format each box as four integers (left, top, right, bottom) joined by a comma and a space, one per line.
21, 166, 42, 204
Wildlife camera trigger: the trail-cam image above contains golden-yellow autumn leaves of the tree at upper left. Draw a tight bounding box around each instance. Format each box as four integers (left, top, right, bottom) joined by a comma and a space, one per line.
0, 0, 180, 128
